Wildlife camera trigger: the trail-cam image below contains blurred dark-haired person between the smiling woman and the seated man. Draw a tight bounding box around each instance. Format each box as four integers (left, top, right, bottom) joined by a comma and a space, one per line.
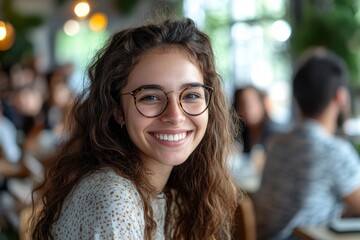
233, 85, 286, 175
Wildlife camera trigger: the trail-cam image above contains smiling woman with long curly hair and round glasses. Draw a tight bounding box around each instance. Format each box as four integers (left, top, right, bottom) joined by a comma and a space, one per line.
32, 16, 240, 239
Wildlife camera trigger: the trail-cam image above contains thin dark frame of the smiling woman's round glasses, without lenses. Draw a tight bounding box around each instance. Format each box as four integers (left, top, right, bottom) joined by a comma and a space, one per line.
120, 83, 214, 118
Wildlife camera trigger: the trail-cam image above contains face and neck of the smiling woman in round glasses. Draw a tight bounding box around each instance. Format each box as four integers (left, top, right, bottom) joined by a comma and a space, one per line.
115, 46, 211, 187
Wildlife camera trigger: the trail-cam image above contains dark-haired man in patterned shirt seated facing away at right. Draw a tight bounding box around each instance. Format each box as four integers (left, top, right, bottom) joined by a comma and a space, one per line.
254, 48, 360, 240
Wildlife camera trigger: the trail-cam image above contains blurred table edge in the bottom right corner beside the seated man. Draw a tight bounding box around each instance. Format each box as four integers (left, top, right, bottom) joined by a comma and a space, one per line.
294, 226, 360, 240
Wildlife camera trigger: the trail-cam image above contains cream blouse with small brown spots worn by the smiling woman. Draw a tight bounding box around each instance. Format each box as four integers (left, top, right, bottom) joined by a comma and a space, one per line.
52, 170, 166, 240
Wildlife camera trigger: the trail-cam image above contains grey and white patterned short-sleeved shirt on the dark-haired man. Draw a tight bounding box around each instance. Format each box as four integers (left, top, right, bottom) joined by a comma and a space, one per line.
254, 121, 360, 240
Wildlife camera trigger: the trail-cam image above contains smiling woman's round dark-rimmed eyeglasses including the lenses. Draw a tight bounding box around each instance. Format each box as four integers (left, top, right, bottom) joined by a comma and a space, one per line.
120, 84, 213, 118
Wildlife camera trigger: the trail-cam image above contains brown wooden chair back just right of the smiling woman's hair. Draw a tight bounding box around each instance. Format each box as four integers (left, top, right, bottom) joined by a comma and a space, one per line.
233, 196, 256, 240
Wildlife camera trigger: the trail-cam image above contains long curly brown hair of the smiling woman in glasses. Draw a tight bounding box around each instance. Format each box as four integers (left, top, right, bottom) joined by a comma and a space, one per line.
32, 19, 239, 239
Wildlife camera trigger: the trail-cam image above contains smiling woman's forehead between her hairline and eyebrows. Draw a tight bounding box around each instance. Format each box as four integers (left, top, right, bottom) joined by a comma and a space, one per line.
124, 46, 204, 90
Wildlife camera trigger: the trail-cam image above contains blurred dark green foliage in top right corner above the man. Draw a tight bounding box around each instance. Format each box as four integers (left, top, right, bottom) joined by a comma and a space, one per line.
290, 0, 360, 87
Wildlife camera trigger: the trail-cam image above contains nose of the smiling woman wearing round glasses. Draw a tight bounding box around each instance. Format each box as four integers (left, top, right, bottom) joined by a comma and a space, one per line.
160, 94, 185, 124
